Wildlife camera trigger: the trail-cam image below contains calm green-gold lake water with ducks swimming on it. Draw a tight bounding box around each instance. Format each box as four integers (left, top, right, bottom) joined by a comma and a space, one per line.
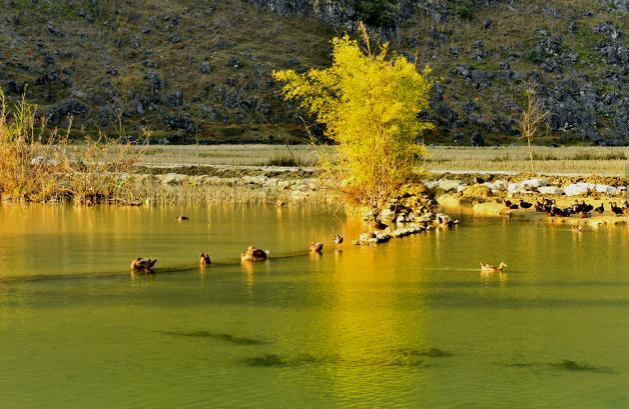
0, 206, 629, 409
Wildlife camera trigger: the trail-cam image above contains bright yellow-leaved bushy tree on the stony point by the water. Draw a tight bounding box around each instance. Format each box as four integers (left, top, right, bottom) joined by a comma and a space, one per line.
273, 26, 433, 206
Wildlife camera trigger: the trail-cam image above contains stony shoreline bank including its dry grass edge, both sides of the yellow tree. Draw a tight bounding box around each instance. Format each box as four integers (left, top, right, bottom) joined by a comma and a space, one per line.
2, 164, 629, 209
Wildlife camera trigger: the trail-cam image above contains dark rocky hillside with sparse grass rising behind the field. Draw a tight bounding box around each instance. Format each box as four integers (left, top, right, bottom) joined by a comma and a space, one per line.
0, 0, 629, 144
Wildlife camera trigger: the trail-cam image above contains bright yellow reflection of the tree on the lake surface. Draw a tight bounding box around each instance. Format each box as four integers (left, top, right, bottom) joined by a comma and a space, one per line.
310, 233, 428, 407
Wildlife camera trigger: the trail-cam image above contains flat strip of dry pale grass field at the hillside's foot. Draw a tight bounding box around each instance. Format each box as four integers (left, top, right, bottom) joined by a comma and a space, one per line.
138, 145, 629, 176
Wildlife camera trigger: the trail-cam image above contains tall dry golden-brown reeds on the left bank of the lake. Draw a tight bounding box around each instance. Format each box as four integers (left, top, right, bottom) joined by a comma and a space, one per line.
0, 89, 141, 205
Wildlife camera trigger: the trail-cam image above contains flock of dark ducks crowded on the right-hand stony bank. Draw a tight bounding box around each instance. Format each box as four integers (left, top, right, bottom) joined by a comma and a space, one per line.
504, 197, 629, 218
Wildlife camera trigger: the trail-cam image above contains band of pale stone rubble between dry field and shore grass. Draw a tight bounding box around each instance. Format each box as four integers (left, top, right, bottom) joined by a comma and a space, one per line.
129, 165, 629, 203
